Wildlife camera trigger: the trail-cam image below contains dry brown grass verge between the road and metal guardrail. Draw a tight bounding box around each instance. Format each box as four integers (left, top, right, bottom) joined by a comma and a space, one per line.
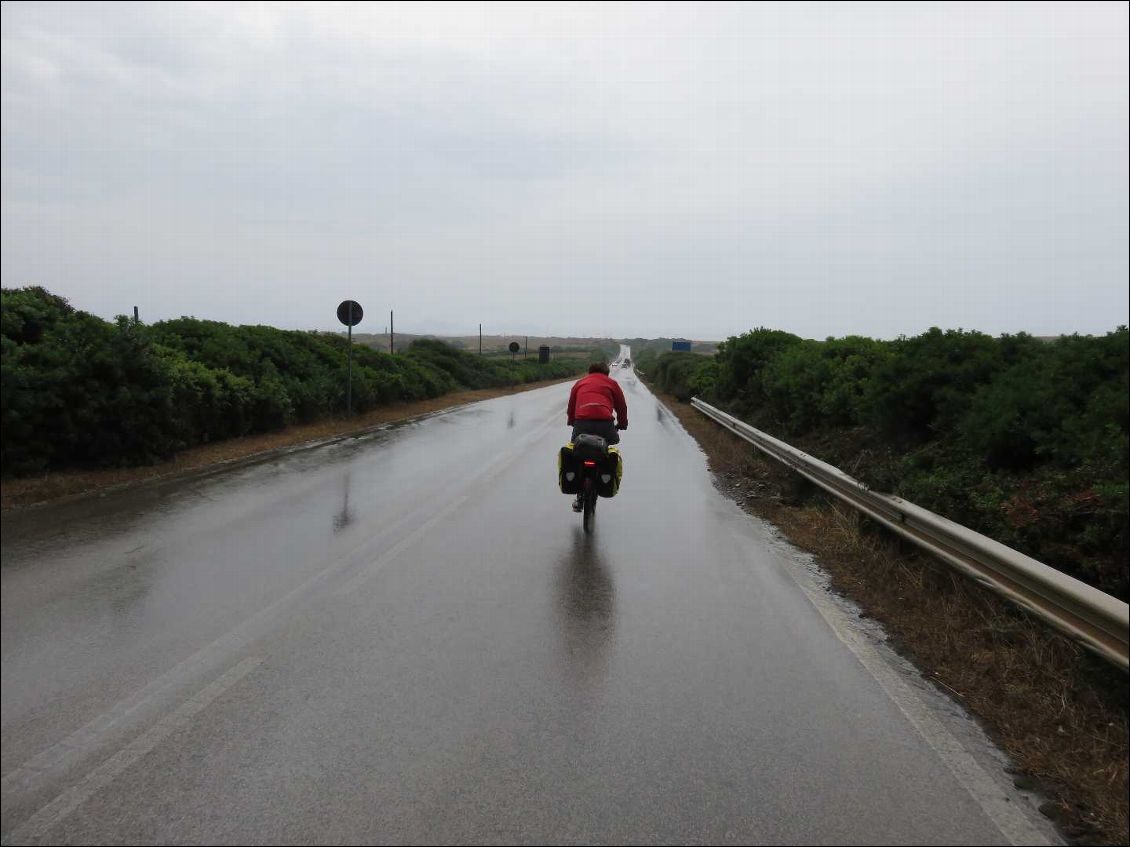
662, 396, 1130, 844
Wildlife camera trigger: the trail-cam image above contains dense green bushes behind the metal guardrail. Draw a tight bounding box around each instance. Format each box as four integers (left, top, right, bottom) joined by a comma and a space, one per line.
636, 326, 1130, 600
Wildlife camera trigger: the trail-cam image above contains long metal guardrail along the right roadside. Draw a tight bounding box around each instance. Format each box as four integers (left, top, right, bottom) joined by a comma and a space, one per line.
690, 398, 1130, 671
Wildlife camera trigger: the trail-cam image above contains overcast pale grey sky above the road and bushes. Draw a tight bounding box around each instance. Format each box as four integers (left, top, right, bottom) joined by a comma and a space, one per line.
2, 2, 1130, 338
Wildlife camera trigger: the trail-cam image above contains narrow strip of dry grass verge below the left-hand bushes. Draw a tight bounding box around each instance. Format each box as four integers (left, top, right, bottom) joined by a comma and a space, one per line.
0, 377, 575, 509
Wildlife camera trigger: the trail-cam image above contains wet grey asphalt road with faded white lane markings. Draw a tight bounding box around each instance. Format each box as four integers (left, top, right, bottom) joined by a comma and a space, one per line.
2, 370, 1048, 844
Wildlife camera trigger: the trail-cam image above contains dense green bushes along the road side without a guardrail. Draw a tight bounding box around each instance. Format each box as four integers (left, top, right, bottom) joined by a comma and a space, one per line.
0, 288, 585, 475
